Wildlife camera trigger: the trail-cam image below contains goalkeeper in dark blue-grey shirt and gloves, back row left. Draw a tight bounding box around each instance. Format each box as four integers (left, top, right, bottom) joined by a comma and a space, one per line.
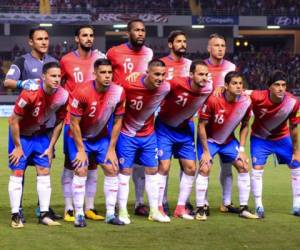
4, 27, 62, 223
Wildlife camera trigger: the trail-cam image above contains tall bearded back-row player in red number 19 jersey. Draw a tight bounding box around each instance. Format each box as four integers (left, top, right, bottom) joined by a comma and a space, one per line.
107, 19, 153, 216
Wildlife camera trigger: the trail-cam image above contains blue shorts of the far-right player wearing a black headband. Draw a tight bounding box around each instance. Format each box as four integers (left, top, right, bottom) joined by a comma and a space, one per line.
250, 136, 300, 168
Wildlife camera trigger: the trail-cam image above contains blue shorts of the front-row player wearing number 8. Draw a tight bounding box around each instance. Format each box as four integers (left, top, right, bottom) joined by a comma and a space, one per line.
8, 129, 50, 170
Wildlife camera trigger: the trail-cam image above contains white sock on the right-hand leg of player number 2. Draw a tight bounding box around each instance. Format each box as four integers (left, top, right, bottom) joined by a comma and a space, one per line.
104, 176, 119, 217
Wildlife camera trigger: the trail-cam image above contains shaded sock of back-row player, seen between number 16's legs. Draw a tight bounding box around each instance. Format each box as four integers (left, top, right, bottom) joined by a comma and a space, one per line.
220, 161, 233, 206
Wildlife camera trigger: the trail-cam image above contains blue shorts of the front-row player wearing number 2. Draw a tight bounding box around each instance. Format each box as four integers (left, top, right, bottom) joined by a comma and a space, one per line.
66, 135, 110, 168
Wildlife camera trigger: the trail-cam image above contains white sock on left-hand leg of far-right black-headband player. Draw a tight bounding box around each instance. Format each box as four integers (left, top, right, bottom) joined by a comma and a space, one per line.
251, 169, 264, 208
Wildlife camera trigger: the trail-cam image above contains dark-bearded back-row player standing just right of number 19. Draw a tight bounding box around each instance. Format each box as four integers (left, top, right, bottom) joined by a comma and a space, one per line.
161, 30, 193, 214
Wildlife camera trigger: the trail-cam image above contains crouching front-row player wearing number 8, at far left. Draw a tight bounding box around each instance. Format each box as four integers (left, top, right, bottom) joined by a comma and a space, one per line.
8, 62, 68, 228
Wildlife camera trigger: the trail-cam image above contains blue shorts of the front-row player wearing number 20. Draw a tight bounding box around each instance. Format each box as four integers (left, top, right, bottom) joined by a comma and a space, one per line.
117, 133, 158, 169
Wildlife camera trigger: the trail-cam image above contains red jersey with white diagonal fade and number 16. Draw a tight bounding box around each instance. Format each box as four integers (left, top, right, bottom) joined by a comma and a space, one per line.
199, 94, 251, 144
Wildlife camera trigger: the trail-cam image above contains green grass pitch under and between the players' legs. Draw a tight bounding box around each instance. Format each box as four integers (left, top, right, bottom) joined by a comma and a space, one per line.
0, 118, 300, 250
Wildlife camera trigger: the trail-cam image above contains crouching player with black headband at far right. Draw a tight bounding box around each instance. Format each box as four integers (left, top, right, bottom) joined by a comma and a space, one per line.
250, 70, 300, 218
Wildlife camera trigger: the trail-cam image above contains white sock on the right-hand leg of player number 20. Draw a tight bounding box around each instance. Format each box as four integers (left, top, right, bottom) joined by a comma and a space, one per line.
145, 174, 158, 211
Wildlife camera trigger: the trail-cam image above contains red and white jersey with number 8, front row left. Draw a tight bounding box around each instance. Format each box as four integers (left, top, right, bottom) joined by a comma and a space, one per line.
14, 83, 69, 136
